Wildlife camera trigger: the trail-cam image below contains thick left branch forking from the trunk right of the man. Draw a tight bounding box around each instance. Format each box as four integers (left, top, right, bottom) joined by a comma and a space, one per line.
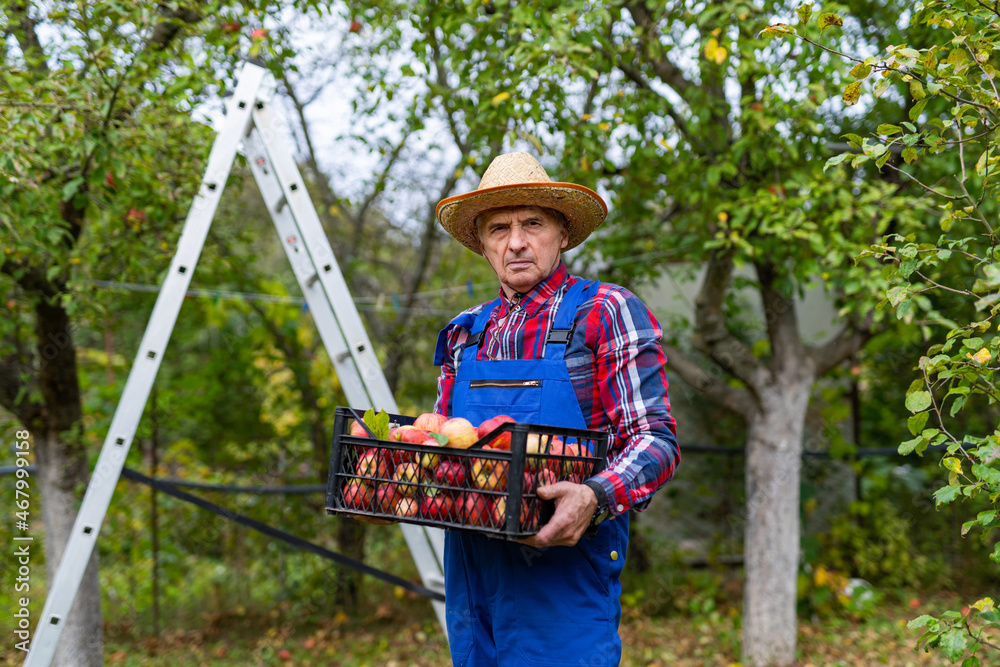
694, 250, 772, 393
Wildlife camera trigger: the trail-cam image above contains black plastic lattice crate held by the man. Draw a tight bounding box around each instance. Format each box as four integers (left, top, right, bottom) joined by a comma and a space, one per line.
326, 407, 608, 539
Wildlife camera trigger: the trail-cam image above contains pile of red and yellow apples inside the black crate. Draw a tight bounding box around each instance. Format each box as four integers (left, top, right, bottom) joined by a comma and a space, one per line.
344, 413, 588, 530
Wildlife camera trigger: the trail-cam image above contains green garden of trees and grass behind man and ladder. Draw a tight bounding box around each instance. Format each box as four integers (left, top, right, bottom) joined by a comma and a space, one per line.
0, 0, 1000, 665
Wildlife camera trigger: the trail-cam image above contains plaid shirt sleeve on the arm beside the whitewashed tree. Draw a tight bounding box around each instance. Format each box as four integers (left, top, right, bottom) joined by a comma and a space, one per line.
591, 288, 681, 516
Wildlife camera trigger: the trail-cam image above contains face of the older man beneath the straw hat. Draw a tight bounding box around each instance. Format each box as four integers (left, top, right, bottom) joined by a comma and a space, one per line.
479, 206, 569, 296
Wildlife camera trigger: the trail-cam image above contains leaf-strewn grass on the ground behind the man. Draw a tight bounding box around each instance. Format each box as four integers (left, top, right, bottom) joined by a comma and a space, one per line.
3, 597, 980, 667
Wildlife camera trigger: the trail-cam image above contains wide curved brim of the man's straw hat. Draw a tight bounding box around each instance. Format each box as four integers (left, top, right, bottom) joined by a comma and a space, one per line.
437, 181, 608, 255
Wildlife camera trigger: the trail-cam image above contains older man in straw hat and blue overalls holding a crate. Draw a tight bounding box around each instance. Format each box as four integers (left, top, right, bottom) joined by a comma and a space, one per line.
435, 153, 680, 667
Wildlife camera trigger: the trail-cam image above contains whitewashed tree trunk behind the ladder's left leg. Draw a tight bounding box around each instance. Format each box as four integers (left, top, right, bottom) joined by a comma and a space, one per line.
32, 433, 103, 667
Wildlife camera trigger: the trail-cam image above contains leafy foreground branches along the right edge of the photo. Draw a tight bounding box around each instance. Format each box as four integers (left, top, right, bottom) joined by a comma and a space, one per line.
792, 1, 1000, 665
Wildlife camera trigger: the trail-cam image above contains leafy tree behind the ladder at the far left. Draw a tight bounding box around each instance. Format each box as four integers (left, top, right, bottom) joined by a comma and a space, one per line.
0, 0, 328, 665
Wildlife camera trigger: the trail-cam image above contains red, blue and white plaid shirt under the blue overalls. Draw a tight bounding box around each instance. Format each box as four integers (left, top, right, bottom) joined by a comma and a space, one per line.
434, 263, 681, 515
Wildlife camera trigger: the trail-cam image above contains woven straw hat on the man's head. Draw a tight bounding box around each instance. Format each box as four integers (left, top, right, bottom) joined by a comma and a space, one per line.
437, 153, 608, 255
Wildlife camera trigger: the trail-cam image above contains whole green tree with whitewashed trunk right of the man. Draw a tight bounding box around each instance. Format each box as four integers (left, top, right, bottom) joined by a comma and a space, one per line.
342, 0, 916, 664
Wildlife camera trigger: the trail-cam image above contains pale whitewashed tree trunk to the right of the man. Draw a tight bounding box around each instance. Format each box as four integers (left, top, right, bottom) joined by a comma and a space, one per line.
743, 374, 813, 667
